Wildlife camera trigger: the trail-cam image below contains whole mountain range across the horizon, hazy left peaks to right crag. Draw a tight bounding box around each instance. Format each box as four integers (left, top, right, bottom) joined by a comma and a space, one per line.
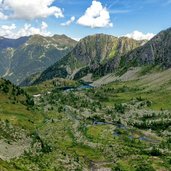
0, 29, 171, 86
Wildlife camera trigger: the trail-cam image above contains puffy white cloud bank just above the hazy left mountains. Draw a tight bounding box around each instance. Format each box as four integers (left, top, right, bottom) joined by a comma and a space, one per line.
0, 22, 51, 39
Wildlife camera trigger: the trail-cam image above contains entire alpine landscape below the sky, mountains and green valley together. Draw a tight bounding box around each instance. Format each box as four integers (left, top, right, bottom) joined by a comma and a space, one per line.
0, 28, 171, 171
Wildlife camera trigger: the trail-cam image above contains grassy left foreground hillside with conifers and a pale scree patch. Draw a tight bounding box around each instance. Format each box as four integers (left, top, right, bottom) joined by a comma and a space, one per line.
0, 79, 42, 168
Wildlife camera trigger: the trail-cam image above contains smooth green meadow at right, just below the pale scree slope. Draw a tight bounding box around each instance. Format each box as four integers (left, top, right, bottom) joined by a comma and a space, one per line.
91, 81, 171, 110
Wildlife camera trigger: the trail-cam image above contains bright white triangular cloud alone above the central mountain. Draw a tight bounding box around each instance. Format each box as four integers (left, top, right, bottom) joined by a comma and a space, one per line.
77, 0, 113, 28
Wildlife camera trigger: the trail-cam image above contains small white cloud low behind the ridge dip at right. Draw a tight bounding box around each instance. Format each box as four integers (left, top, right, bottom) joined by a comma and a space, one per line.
125, 31, 155, 40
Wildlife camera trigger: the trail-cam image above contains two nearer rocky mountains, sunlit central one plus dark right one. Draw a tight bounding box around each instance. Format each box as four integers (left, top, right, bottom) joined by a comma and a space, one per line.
35, 29, 171, 84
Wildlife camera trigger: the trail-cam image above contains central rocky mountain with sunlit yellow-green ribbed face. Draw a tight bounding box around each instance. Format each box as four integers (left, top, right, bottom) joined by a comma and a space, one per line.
35, 34, 144, 83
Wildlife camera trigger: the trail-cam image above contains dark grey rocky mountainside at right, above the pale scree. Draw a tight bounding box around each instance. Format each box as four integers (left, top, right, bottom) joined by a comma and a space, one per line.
83, 29, 171, 79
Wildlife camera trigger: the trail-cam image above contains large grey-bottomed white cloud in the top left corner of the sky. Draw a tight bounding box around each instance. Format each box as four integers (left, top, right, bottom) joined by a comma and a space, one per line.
0, 0, 63, 20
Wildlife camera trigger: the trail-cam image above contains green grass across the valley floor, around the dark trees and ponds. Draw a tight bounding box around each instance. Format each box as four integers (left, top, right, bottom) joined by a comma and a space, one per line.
0, 75, 171, 171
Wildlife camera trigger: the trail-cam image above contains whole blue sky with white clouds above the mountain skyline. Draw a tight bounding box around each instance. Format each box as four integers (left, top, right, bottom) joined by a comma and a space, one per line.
0, 0, 171, 40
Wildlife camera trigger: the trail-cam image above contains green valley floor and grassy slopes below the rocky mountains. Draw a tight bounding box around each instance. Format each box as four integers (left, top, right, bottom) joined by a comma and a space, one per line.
0, 68, 171, 171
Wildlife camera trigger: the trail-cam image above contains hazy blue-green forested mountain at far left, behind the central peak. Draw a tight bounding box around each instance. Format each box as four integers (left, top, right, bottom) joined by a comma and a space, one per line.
0, 35, 77, 85
